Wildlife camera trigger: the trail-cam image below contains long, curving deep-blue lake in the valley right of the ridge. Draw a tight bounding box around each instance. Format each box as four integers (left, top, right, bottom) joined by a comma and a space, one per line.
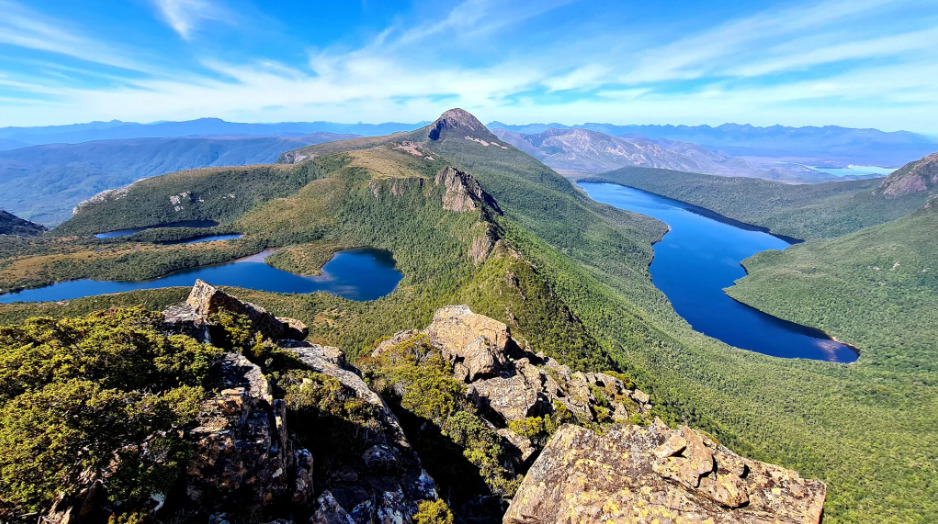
579, 182, 857, 362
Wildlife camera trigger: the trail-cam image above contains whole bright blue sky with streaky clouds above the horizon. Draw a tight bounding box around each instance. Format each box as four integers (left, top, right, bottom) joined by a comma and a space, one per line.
0, 0, 938, 135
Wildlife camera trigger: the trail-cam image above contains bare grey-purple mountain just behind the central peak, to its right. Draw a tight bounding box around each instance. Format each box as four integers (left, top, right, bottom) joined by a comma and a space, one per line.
492, 128, 857, 183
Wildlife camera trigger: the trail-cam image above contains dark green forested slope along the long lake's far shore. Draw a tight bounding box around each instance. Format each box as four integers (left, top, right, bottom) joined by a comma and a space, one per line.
589, 167, 927, 239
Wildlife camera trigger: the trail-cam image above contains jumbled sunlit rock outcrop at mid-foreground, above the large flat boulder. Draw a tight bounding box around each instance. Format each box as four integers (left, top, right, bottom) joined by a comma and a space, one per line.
372, 306, 651, 426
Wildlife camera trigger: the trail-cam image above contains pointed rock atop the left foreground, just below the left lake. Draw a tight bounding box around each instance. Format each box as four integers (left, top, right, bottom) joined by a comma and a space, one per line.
182, 280, 309, 340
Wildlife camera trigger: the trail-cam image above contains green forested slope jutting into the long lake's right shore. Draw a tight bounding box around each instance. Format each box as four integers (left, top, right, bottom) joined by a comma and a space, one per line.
727, 199, 938, 374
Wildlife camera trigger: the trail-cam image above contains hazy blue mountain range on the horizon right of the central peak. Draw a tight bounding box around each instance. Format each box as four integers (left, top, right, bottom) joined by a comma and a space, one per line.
489, 122, 936, 167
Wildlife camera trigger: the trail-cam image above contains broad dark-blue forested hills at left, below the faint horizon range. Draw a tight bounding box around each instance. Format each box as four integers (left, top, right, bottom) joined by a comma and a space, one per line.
0, 132, 355, 225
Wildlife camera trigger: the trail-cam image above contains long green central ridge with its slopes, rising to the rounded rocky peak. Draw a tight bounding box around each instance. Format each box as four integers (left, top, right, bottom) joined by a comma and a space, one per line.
0, 111, 938, 523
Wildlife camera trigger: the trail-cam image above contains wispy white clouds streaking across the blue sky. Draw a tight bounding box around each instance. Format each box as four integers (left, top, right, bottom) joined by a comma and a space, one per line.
0, 0, 938, 131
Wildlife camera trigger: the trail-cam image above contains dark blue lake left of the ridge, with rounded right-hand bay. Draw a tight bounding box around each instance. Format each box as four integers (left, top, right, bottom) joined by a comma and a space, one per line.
0, 249, 404, 303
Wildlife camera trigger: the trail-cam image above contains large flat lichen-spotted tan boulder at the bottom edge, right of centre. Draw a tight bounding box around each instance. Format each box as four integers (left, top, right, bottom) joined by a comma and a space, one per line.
504, 424, 826, 524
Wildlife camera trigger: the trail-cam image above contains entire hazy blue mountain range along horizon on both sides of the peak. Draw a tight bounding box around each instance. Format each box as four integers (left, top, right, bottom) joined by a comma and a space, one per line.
0, 118, 938, 167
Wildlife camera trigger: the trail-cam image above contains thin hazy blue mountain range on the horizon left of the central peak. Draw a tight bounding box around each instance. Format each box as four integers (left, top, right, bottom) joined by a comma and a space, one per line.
0, 118, 426, 145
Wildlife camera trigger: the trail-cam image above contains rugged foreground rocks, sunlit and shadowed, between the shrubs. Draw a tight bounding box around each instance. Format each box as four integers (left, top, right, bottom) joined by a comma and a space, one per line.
43, 281, 826, 524
